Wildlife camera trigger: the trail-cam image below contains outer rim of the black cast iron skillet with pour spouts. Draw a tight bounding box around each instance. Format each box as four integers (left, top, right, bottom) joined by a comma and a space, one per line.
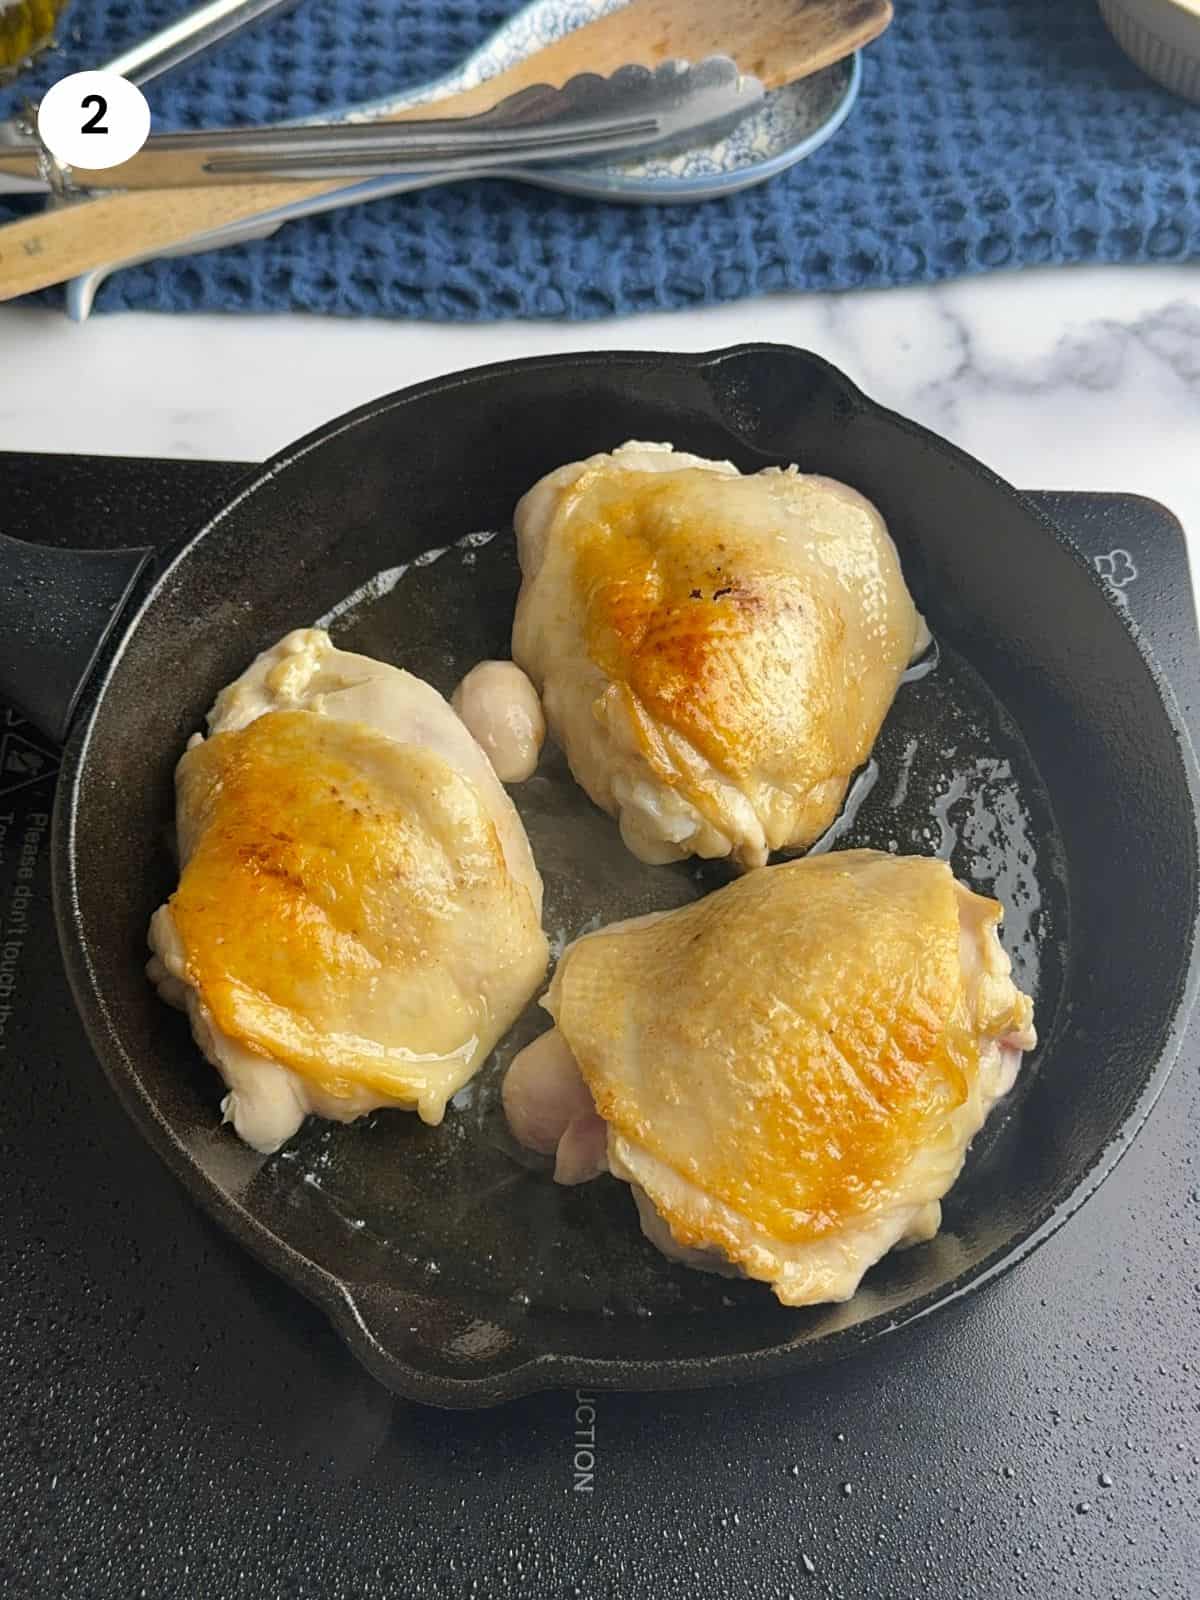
53, 341, 1200, 1408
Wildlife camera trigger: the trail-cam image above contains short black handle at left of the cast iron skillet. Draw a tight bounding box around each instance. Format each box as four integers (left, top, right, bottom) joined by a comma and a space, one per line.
0, 533, 154, 744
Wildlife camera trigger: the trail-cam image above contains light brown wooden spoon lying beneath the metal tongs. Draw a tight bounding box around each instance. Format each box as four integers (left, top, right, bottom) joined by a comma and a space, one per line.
0, 0, 891, 301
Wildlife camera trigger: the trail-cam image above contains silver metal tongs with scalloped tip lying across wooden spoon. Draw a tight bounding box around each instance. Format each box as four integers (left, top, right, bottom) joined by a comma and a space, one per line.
0, 56, 765, 195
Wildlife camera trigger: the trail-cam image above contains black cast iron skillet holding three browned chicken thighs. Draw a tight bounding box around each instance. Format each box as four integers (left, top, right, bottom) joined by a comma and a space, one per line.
0, 346, 1197, 1406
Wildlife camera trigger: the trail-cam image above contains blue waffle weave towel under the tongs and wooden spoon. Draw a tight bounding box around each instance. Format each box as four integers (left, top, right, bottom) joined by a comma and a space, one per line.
2, 0, 1200, 320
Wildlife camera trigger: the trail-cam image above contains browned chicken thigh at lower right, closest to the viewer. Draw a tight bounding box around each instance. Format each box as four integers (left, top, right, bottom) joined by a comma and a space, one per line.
502, 850, 1037, 1306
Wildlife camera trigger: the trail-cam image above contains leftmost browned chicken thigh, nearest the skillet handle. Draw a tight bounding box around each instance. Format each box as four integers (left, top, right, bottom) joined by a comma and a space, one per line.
149, 629, 547, 1150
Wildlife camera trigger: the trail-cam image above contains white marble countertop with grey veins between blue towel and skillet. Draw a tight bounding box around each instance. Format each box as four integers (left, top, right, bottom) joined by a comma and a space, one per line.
0, 267, 1200, 570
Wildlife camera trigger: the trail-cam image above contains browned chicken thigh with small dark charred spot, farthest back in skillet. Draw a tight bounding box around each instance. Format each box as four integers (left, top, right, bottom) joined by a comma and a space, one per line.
512, 442, 928, 866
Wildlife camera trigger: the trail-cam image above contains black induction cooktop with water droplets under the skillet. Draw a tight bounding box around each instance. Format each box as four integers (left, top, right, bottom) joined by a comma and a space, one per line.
0, 454, 1200, 1600
